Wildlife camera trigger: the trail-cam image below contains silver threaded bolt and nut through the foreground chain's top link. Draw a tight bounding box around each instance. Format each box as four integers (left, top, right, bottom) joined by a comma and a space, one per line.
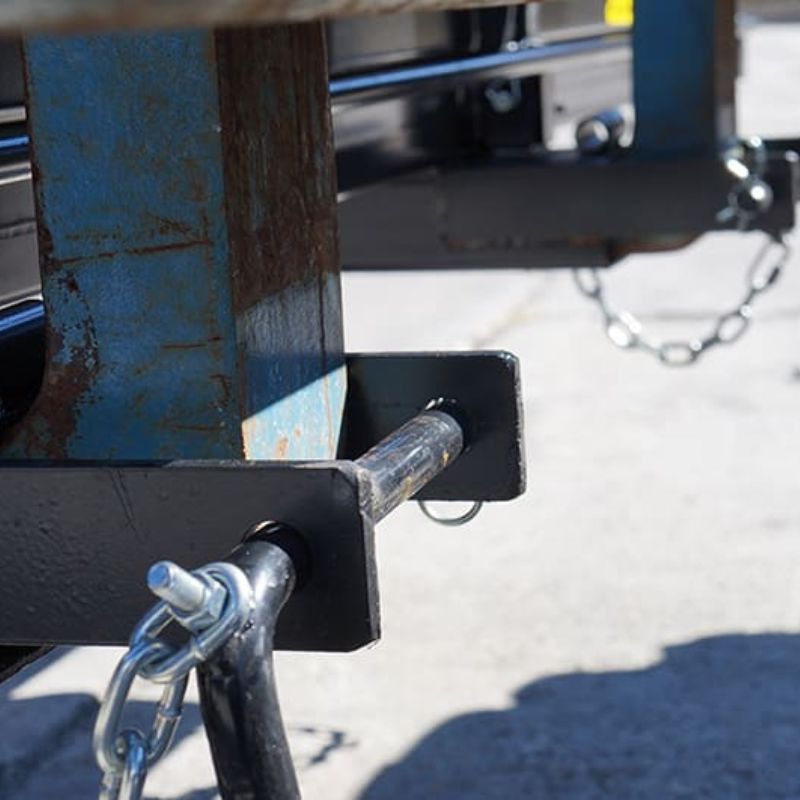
147, 561, 227, 631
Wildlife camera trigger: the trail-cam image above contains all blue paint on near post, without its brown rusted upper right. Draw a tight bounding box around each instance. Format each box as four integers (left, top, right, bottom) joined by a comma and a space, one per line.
4, 31, 344, 459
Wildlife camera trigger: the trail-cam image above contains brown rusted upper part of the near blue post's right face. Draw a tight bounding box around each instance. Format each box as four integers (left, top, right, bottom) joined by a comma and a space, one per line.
216, 24, 338, 312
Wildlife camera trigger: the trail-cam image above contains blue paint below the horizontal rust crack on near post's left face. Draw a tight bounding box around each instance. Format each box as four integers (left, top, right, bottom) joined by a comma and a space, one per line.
45, 249, 241, 459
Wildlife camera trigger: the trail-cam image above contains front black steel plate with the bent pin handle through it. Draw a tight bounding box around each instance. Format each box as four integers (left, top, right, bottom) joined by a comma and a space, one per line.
0, 462, 379, 651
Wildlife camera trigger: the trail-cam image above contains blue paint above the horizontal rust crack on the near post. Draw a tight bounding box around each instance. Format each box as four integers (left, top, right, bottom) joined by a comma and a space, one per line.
26, 31, 226, 262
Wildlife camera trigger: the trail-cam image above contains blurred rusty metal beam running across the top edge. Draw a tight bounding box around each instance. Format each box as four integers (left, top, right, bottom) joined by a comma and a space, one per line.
0, 0, 547, 32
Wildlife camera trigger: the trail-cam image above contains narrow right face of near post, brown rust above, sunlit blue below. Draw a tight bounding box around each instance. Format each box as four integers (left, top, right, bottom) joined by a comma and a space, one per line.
216, 23, 345, 459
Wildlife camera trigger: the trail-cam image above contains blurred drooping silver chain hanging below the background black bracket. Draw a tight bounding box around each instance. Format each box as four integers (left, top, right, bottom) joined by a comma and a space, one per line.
572, 234, 790, 367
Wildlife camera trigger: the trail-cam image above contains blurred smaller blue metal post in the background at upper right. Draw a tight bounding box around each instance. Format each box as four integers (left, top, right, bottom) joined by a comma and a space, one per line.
633, 0, 737, 158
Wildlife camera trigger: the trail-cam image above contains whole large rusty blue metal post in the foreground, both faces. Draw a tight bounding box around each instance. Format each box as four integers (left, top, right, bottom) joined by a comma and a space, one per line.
0, 23, 345, 460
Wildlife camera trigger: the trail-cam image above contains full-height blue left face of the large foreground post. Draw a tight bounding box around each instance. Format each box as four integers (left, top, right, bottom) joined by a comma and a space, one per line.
4, 32, 241, 458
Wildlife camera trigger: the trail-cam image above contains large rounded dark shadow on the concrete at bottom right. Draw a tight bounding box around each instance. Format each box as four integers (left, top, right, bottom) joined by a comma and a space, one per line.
361, 634, 800, 800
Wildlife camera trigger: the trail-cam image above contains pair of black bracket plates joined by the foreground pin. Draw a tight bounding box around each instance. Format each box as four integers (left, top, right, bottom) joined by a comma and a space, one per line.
0, 353, 524, 651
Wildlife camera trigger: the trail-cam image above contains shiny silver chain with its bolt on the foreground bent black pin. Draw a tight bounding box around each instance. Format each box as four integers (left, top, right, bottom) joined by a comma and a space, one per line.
93, 562, 253, 800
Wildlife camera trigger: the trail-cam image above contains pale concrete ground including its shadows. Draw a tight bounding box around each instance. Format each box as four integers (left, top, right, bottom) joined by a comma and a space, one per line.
0, 17, 800, 800
